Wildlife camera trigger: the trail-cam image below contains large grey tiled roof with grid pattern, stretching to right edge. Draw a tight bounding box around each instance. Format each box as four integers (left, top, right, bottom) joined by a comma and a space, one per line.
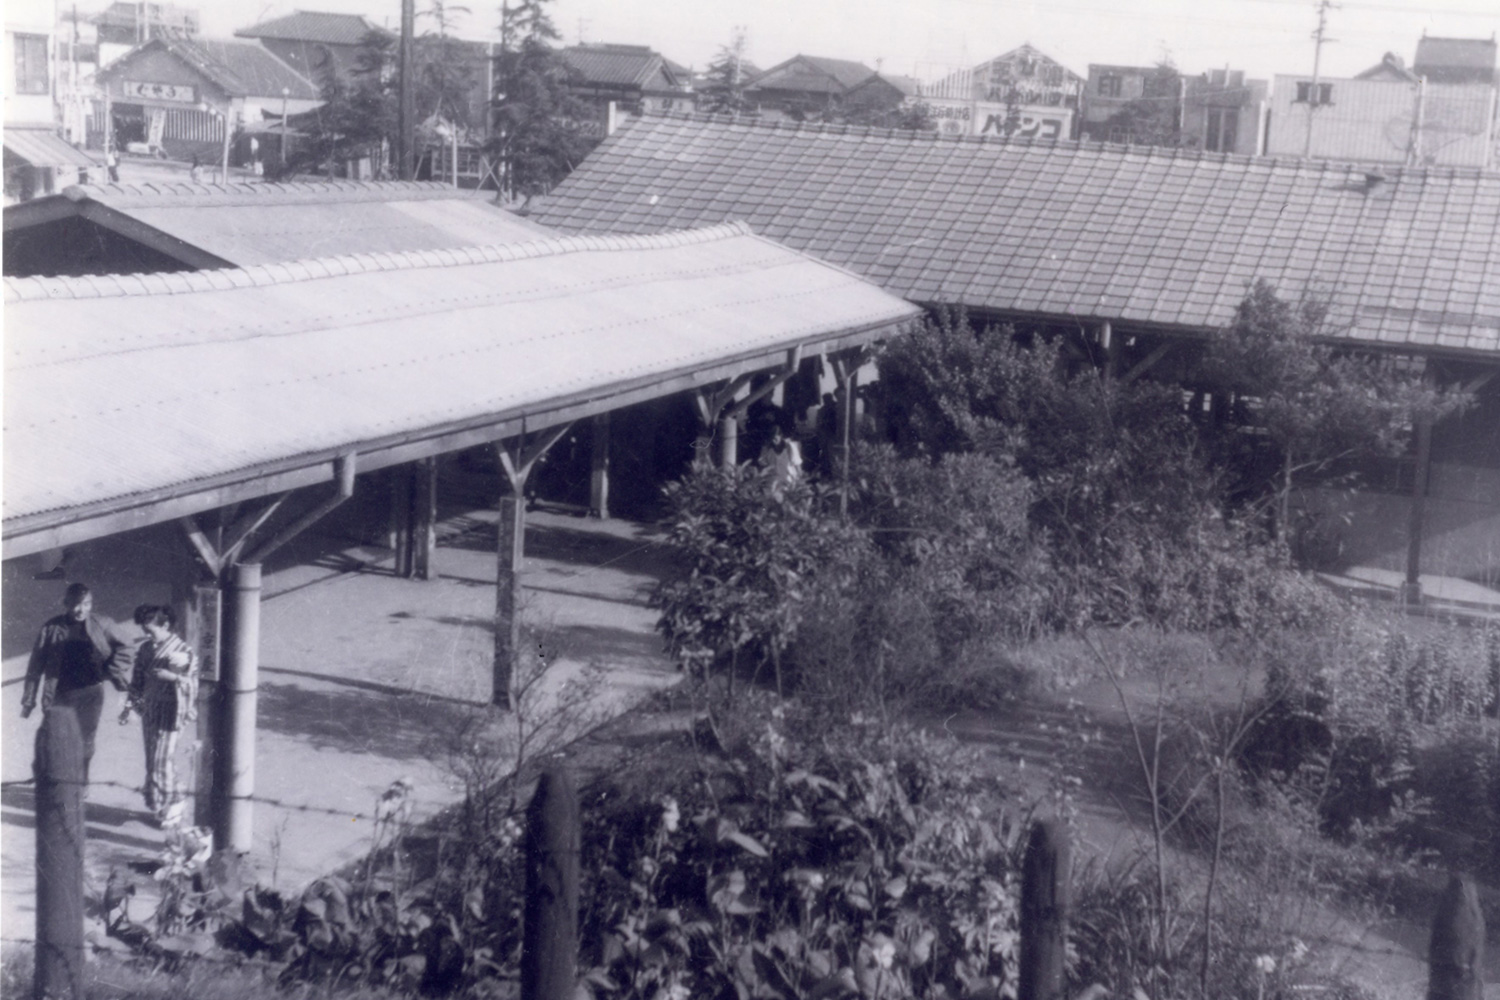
533, 115, 1500, 355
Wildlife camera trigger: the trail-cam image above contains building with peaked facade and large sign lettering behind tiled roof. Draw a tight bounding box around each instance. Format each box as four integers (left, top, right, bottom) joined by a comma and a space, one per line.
923, 43, 1083, 139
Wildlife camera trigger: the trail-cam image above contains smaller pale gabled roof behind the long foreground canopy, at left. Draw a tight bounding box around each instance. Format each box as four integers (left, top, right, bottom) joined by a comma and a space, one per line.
6, 181, 554, 273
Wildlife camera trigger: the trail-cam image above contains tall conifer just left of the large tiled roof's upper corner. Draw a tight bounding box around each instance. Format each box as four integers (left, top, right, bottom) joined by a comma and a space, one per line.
491, 0, 597, 196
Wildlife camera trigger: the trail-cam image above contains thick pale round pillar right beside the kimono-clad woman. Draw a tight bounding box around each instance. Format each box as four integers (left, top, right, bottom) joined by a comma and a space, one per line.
213, 562, 261, 853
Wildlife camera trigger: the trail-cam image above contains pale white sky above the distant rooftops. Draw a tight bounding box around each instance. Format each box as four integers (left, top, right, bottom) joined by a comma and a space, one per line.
170, 0, 1500, 78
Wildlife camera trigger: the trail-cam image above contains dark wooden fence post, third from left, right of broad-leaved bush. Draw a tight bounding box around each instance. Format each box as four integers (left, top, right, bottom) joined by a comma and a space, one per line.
1017, 820, 1073, 1000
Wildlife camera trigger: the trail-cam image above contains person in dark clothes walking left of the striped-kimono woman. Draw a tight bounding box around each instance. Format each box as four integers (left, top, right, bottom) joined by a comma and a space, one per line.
21, 583, 135, 777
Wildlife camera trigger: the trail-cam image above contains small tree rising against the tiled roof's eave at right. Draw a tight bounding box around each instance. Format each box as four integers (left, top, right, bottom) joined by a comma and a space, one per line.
1200, 280, 1473, 537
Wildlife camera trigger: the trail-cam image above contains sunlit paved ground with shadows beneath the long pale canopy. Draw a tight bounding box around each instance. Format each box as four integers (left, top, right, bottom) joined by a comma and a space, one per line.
0, 510, 680, 942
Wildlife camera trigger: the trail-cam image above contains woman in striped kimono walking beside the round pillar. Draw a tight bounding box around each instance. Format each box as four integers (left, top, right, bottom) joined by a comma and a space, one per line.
120, 604, 198, 826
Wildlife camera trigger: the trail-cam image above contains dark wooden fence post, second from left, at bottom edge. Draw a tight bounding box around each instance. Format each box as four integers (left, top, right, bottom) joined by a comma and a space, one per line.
521, 768, 579, 1000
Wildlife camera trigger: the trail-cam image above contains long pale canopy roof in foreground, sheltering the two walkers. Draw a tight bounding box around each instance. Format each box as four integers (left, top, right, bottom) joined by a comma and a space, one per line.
3, 223, 918, 558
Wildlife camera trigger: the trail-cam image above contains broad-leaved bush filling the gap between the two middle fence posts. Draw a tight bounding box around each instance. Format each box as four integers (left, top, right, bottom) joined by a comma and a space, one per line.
582, 706, 1022, 997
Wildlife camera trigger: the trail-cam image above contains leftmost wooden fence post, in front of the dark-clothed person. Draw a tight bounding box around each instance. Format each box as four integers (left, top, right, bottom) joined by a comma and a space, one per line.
32, 705, 84, 1000
